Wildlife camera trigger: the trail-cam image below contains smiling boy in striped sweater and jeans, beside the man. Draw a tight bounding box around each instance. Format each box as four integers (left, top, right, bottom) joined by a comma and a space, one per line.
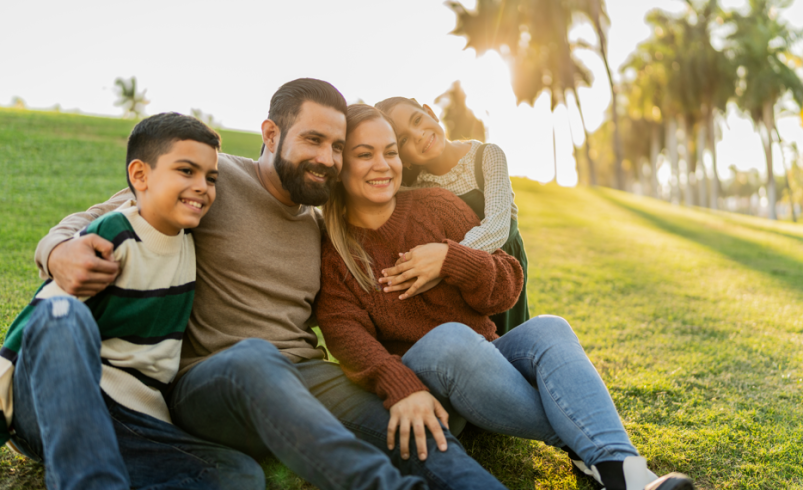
0, 113, 265, 490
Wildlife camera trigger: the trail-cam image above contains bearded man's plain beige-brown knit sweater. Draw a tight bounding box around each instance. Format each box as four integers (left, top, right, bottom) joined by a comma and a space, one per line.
36, 153, 323, 376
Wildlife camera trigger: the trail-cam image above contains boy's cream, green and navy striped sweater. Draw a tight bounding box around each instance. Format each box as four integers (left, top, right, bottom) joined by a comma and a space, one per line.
0, 201, 195, 444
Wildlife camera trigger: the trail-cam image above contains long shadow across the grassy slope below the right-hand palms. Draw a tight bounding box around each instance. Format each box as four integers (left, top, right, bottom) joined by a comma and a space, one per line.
597, 192, 803, 292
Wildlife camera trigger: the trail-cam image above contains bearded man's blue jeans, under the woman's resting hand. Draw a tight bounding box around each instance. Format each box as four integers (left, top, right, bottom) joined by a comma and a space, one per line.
169, 339, 504, 490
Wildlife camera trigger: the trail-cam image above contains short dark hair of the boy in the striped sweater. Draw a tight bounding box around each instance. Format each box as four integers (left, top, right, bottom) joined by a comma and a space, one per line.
125, 112, 220, 192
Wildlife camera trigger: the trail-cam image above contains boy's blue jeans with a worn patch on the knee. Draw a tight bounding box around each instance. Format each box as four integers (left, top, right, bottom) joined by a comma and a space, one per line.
11, 297, 265, 490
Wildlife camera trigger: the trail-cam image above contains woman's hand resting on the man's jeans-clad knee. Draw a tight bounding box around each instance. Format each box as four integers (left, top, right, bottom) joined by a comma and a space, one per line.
388, 391, 449, 461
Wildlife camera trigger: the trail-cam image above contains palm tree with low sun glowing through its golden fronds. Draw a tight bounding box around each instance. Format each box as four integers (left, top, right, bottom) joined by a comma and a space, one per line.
447, 0, 596, 184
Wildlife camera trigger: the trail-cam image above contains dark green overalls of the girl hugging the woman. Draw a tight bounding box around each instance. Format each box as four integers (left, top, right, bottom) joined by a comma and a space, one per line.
457, 145, 530, 336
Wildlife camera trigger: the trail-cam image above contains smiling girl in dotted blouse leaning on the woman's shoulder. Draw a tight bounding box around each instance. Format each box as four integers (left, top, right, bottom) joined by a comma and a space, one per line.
376, 97, 530, 335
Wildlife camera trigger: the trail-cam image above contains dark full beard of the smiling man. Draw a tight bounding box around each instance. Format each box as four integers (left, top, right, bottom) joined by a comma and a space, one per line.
273, 135, 337, 206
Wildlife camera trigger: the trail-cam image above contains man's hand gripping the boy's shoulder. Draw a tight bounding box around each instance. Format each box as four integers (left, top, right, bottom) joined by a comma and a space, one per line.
47, 234, 120, 297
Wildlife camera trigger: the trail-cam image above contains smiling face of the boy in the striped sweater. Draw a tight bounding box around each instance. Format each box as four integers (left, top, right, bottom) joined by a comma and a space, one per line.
129, 140, 218, 235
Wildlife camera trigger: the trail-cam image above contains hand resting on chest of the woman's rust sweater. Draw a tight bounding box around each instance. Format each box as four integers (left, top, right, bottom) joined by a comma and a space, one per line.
379, 243, 449, 299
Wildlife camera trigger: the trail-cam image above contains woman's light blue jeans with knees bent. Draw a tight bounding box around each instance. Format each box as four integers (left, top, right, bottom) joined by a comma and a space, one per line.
402, 316, 638, 466
